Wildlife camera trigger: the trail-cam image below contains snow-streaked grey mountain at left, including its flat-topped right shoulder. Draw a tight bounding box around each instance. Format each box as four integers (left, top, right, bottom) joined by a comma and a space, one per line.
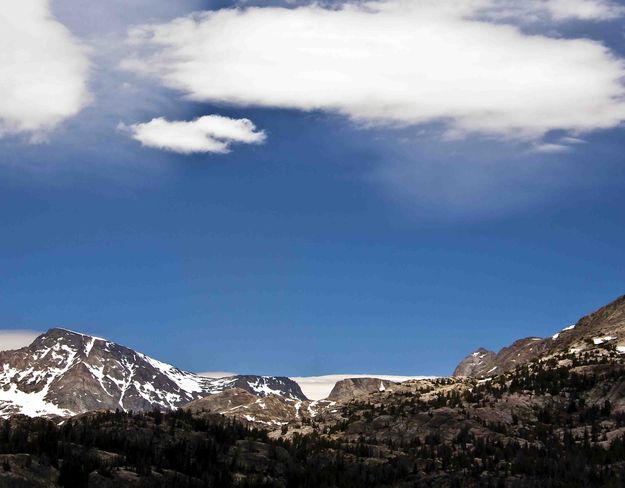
0, 328, 306, 416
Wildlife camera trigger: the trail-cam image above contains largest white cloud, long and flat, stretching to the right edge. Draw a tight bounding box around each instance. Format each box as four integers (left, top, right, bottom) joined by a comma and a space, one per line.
123, 0, 625, 138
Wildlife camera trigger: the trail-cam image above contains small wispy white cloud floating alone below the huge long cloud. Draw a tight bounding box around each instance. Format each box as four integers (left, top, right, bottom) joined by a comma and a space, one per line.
120, 115, 265, 154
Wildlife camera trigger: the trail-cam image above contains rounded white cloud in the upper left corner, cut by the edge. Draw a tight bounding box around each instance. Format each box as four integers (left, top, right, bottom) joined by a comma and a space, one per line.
0, 0, 89, 138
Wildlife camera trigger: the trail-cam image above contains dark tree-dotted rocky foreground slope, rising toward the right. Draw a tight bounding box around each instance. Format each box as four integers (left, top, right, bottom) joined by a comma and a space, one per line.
0, 300, 625, 488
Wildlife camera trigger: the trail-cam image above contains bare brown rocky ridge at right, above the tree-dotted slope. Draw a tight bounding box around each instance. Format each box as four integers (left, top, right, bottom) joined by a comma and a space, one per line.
453, 296, 625, 377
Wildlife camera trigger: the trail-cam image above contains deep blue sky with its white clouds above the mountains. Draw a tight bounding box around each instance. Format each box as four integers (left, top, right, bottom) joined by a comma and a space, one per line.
0, 0, 625, 376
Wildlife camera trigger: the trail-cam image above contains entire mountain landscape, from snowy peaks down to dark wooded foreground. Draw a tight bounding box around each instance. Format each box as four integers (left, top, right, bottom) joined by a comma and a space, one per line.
0, 297, 625, 488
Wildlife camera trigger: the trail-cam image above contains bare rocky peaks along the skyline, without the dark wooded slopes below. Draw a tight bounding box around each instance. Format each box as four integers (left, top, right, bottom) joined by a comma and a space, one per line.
0, 297, 625, 425
